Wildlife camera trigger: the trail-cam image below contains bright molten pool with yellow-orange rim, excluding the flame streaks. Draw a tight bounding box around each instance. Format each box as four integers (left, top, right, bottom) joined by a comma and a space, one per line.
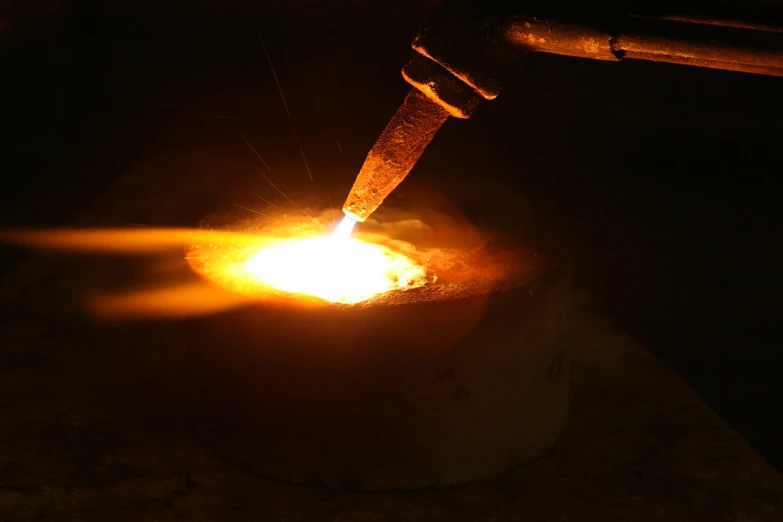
188, 209, 444, 305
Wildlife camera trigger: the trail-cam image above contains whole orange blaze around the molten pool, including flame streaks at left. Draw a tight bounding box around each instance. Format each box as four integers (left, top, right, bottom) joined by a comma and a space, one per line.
0, 202, 520, 320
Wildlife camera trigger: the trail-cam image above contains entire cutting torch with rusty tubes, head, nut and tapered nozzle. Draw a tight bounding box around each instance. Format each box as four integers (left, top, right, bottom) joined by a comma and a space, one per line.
343, 0, 783, 226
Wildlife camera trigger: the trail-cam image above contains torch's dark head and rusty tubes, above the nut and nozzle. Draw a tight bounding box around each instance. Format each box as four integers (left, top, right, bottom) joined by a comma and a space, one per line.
413, 0, 783, 100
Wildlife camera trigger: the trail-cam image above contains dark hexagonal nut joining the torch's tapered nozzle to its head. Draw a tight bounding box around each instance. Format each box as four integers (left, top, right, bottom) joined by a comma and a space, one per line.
402, 56, 481, 119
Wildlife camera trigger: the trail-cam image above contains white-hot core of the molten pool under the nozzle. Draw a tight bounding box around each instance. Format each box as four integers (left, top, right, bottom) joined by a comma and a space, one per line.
241, 234, 426, 304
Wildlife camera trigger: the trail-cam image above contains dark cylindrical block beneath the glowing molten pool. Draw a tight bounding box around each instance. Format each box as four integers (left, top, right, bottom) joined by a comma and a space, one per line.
186, 205, 571, 490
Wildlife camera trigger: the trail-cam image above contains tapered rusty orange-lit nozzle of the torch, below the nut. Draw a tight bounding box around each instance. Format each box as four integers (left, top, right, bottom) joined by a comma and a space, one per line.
343, 89, 449, 221
